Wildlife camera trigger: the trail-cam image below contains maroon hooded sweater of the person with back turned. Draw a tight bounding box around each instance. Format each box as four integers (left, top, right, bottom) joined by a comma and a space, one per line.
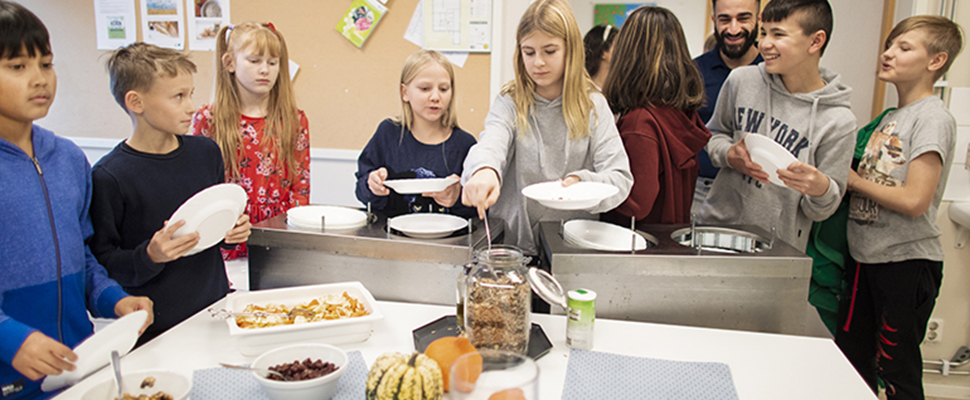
602, 106, 711, 226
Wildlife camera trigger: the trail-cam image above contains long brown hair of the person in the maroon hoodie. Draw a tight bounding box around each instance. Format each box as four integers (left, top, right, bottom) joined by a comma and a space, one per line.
603, 6, 705, 116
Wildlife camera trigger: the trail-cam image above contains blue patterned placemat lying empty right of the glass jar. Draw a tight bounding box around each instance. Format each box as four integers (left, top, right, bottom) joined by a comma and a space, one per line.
562, 350, 738, 400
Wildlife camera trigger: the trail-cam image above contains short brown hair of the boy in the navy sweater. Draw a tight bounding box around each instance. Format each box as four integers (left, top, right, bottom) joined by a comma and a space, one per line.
105, 42, 196, 111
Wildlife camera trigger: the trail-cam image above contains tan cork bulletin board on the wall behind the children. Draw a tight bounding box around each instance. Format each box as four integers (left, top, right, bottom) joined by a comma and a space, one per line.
20, 0, 491, 150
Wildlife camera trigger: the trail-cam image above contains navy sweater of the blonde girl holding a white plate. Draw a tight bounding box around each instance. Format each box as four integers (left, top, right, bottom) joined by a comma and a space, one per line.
356, 119, 475, 217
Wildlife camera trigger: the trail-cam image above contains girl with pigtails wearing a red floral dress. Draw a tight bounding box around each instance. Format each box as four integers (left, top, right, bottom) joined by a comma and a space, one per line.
192, 22, 310, 259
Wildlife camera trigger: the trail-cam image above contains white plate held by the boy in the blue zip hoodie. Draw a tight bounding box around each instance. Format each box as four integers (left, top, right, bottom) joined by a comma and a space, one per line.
40, 310, 148, 392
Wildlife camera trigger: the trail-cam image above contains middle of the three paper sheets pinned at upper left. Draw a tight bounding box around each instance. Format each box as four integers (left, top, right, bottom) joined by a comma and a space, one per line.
141, 0, 185, 50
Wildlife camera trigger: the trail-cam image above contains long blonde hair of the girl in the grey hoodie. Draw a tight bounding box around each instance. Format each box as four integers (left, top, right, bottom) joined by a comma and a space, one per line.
501, 0, 595, 139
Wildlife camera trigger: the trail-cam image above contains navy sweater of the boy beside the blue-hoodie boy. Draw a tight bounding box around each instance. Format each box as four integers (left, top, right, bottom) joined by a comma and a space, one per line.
91, 136, 229, 343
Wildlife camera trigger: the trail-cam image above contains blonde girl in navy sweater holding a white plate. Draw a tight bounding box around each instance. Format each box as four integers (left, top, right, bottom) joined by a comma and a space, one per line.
356, 50, 475, 217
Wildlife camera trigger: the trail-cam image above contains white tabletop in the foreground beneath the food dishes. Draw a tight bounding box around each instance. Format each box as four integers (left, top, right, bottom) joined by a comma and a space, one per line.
49, 300, 876, 400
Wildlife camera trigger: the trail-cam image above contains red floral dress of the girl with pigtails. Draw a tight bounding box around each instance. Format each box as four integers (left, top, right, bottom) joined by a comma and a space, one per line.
192, 104, 310, 260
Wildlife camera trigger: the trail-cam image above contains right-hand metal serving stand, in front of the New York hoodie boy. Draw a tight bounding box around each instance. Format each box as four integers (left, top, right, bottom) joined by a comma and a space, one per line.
539, 221, 812, 334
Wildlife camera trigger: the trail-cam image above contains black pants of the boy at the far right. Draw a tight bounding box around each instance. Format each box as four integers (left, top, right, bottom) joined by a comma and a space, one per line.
835, 260, 943, 400
